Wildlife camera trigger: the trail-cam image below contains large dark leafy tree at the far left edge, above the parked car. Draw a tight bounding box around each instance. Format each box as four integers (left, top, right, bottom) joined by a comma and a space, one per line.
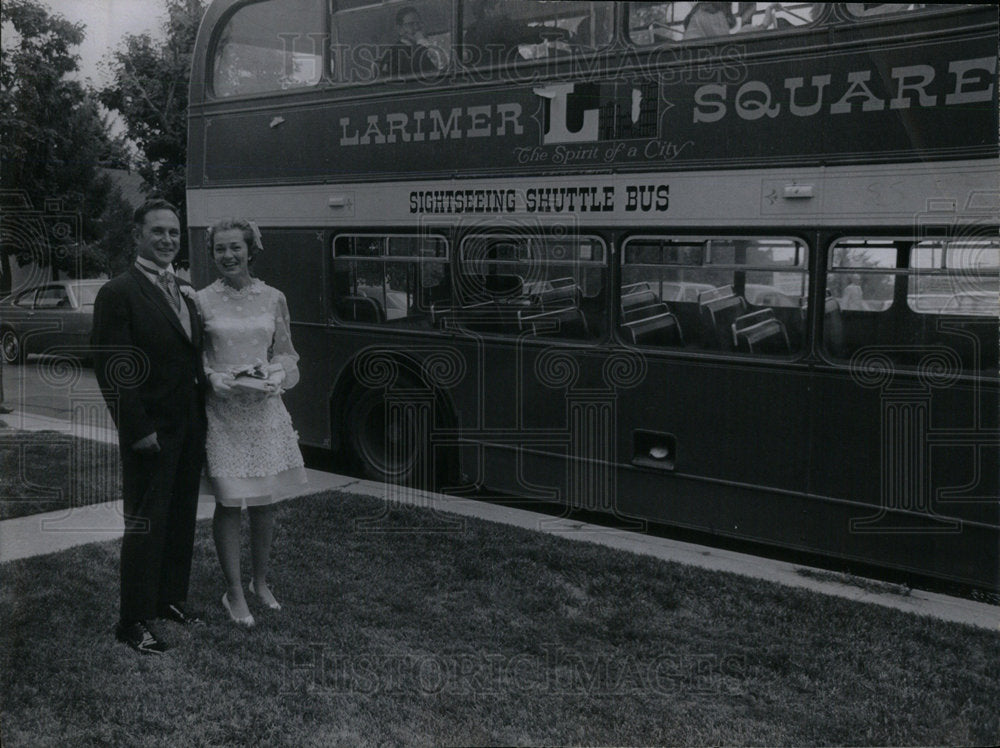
0, 0, 126, 291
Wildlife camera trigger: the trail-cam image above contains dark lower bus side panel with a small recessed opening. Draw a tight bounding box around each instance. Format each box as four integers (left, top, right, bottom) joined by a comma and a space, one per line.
470, 346, 809, 520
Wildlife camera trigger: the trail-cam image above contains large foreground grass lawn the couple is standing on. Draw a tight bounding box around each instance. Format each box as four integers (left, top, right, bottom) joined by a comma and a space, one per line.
0, 493, 1000, 746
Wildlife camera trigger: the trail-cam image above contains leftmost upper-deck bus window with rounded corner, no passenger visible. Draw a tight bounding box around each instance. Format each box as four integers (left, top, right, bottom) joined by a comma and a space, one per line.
212, 0, 326, 97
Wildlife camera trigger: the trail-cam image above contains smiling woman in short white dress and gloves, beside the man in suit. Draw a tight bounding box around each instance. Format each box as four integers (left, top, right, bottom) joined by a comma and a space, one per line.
197, 219, 306, 627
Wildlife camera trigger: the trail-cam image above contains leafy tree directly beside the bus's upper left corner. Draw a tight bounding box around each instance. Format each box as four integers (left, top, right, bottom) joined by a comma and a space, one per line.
100, 0, 205, 219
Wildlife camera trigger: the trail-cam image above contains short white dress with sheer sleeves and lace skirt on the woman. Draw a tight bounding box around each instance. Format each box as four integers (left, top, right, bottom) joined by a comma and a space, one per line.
196, 278, 306, 506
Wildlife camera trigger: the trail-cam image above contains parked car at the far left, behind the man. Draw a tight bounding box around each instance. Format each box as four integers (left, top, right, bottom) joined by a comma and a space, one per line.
0, 280, 107, 364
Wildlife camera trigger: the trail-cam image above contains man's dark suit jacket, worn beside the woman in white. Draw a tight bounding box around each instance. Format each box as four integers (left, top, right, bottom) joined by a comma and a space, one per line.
91, 266, 206, 448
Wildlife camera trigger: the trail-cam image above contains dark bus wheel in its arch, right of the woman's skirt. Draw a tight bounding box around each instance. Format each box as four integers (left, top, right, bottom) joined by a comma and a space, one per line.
344, 389, 433, 488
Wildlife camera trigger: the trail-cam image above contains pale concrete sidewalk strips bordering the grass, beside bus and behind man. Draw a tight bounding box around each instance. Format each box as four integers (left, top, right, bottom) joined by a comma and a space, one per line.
0, 413, 1000, 633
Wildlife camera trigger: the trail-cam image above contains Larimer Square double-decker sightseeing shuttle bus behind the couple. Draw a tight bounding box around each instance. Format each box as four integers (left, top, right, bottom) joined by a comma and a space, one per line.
187, 0, 1000, 592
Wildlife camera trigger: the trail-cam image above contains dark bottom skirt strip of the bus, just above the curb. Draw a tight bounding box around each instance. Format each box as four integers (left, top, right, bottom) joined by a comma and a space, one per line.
500, 436, 1000, 592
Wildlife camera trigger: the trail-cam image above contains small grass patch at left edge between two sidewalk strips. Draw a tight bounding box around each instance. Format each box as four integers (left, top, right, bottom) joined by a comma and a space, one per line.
0, 428, 121, 520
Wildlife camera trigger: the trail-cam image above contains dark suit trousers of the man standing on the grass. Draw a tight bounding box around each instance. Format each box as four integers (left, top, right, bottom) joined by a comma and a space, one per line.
121, 398, 205, 621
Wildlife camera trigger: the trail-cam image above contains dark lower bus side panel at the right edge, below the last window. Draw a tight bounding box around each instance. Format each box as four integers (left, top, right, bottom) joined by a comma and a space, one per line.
809, 370, 1000, 589
